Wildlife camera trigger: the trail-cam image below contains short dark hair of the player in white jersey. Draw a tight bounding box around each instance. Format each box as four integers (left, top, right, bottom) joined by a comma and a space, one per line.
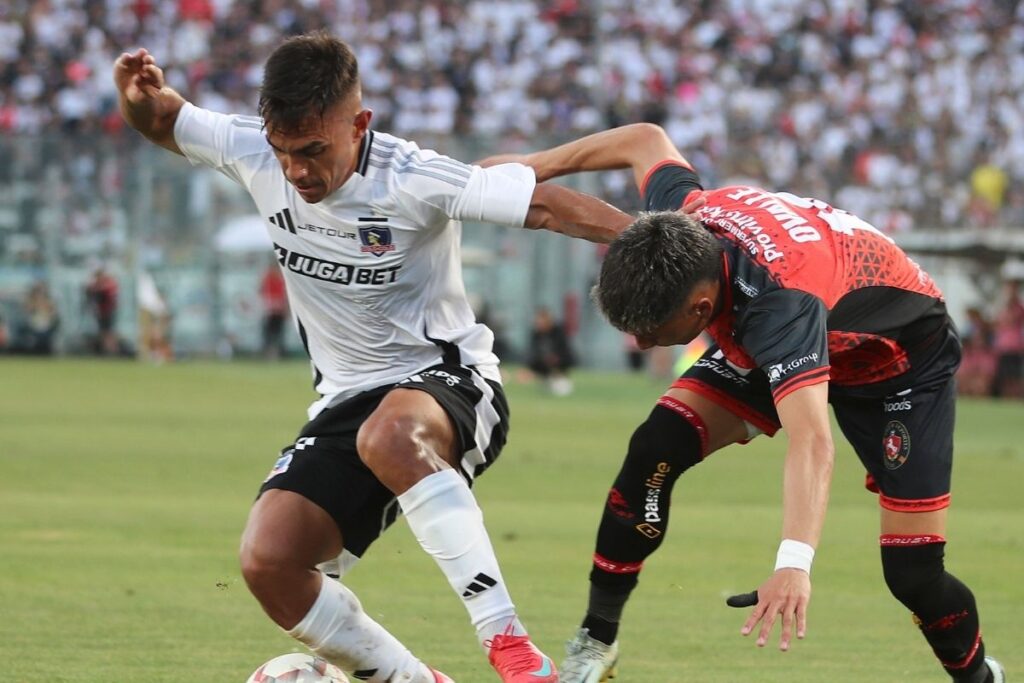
259, 31, 359, 131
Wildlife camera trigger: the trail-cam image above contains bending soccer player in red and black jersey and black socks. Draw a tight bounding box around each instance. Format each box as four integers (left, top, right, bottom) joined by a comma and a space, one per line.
483, 124, 1005, 683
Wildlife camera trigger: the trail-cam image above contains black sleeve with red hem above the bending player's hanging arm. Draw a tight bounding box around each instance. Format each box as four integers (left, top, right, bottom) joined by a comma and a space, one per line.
736, 289, 828, 402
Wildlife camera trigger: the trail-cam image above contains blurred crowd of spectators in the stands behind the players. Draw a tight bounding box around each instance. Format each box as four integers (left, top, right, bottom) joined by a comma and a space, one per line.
0, 0, 1024, 397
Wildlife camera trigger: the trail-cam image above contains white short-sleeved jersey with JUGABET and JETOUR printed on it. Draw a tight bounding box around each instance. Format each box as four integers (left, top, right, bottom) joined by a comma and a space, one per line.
174, 103, 537, 419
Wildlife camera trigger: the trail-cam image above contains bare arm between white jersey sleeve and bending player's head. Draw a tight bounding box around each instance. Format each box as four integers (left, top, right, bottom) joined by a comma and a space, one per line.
523, 183, 633, 243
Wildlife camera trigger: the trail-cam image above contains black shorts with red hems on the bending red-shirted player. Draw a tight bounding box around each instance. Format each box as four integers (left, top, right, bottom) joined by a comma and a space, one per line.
673, 345, 956, 512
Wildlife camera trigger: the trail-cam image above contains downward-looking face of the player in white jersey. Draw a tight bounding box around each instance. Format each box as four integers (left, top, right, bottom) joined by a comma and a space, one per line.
266, 95, 373, 204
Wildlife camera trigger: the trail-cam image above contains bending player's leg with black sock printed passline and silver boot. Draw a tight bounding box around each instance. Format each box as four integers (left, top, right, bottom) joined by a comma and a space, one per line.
561, 388, 751, 683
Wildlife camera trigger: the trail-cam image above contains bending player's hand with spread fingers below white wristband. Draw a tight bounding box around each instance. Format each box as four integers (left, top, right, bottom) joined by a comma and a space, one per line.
739, 568, 811, 651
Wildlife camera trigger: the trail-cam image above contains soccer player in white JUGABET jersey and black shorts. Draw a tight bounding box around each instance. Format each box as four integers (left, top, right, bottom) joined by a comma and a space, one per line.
114, 33, 630, 683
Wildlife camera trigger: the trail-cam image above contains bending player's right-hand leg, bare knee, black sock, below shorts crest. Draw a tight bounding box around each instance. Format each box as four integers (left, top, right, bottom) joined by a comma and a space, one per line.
881, 508, 1005, 683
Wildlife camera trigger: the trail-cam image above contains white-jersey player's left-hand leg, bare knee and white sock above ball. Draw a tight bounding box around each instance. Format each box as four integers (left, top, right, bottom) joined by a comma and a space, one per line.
240, 489, 443, 683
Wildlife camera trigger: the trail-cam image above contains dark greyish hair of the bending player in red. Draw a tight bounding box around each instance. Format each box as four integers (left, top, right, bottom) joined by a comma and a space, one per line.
591, 211, 722, 334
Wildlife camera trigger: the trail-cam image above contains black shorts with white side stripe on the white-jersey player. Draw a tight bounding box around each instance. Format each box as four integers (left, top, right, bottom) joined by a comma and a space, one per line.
260, 365, 509, 557
